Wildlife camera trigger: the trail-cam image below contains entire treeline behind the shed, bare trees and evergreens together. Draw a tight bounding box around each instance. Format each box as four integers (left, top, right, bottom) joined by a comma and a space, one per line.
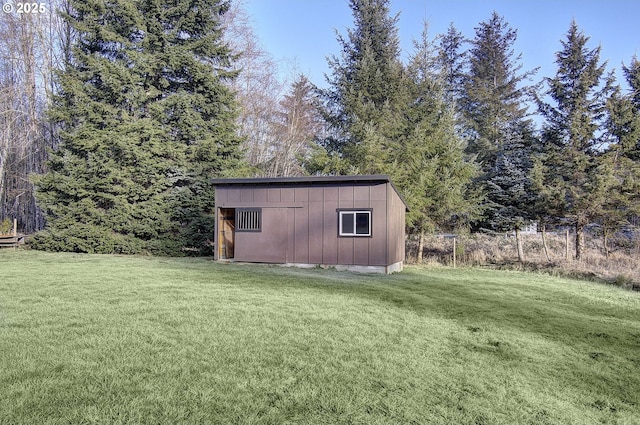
0, 0, 640, 259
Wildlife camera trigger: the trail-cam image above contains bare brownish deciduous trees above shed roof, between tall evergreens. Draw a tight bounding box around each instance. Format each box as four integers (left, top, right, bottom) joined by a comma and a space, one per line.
224, 2, 322, 177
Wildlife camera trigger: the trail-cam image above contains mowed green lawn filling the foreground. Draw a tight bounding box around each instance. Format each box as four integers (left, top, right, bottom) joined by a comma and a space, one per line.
0, 250, 640, 424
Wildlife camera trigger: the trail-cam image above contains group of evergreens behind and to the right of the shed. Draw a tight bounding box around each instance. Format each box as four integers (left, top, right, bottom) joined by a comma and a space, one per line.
308, 0, 640, 259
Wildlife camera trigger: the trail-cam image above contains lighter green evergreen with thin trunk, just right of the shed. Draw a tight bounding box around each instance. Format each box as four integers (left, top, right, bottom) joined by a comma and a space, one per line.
396, 24, 477, 261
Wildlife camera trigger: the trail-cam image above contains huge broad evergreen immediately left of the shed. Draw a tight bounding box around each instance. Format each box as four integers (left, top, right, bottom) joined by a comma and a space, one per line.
35, 0, 239, 254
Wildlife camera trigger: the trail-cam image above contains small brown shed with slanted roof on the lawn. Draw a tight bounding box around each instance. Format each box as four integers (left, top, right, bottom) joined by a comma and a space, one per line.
212, 175, 407, 273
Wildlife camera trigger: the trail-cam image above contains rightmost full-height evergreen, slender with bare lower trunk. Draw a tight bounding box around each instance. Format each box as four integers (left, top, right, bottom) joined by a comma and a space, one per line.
538, 21, 613, 260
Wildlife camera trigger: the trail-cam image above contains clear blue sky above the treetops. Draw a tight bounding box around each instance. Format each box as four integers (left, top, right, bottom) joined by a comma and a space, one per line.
245, 0, 640, 90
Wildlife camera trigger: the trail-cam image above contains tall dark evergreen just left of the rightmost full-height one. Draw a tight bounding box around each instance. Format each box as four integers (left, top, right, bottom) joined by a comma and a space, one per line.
460, 12, 536, 234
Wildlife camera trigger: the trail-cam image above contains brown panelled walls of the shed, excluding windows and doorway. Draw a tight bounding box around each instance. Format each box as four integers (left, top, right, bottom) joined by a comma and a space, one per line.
216, 182, 405, 266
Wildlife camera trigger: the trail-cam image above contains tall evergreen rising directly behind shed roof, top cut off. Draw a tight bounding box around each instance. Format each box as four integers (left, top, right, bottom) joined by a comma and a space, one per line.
310, 0, 406, 174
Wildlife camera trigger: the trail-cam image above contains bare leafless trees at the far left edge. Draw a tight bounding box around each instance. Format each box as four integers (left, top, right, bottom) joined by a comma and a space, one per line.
0, 0, 65, 233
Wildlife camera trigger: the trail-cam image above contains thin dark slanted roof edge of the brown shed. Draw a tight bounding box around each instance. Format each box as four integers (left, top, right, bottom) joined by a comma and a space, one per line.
211, 174, 409, 211
